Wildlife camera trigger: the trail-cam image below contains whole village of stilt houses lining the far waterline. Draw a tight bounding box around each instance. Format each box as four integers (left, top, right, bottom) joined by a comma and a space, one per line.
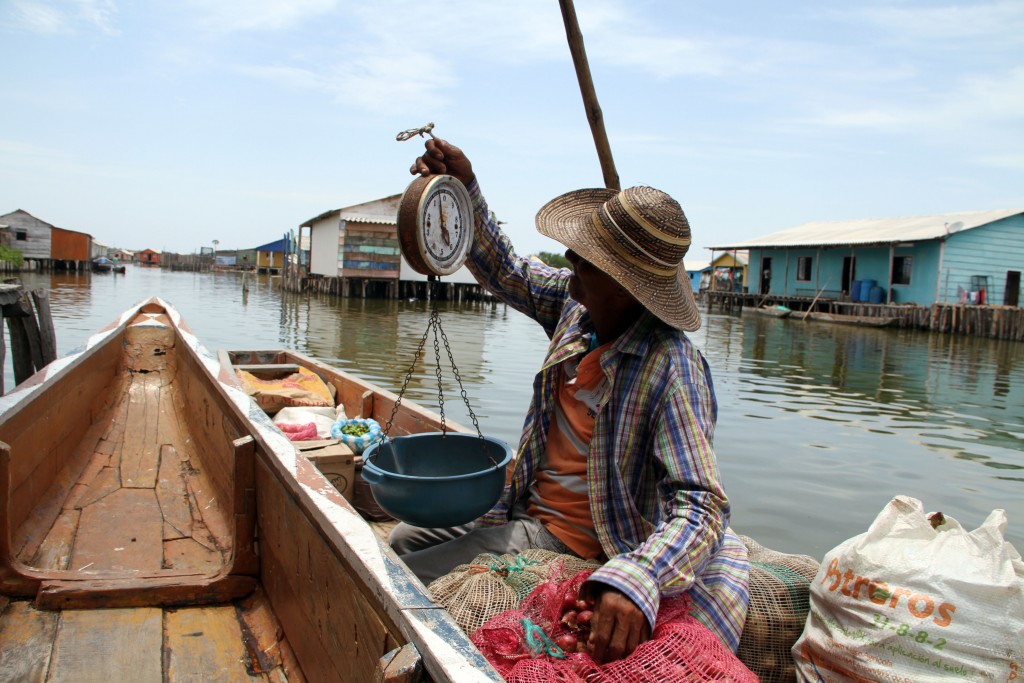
0, 195, 1024, 337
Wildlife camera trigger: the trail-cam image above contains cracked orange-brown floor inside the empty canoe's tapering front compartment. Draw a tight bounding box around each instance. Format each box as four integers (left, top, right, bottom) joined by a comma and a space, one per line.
22, 358, 229, 574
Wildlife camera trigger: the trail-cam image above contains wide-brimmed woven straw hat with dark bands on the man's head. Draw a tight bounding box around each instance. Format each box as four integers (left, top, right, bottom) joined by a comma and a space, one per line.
537, 186, 700, 332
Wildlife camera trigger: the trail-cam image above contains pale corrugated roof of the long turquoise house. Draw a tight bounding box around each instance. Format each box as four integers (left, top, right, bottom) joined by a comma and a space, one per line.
708, 209, 1024, 249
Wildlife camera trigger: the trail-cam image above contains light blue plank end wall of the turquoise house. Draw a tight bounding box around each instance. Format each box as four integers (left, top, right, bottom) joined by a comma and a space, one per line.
939, 214, 1024, 305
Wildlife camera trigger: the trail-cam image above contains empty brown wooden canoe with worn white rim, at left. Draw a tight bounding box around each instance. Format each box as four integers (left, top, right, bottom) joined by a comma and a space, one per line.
0, 299, 501, 682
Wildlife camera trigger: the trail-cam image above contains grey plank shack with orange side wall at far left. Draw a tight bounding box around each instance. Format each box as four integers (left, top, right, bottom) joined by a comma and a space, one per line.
0, 209, 92, 269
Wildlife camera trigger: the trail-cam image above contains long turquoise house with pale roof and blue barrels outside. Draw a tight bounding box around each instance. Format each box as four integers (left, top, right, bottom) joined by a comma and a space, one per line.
711, 209, 1024, 306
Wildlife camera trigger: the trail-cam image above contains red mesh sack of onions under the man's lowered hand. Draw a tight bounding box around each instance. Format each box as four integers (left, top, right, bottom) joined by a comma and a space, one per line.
472, 569, 758, 683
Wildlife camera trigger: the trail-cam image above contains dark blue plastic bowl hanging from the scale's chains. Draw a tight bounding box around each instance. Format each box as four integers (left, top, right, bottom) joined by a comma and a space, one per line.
362, 432, 512, 527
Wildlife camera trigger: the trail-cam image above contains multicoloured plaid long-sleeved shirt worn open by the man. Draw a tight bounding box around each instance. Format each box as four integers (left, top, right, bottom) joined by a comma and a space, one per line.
467, 181, 749, 650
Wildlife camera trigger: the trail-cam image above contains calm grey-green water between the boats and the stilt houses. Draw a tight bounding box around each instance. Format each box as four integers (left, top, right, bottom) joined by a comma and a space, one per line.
4, 266, 1024, 559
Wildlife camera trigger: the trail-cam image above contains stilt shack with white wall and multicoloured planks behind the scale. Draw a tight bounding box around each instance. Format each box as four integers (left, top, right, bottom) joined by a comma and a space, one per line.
300, 195, 401, 297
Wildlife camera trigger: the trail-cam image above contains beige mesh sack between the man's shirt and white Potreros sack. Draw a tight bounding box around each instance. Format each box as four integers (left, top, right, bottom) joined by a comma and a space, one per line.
736, 536, 820, 683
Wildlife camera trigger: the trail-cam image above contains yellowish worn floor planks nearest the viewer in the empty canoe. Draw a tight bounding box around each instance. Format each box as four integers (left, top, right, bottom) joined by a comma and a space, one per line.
0, 590, 296, 683
